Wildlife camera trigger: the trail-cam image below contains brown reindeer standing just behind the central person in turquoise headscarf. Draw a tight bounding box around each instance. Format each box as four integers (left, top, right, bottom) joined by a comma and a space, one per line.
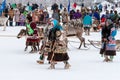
63, 19, 86, 49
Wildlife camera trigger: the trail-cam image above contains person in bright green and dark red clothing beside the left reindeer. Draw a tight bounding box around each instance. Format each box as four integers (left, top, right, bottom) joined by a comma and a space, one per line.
26, 15, 40, 53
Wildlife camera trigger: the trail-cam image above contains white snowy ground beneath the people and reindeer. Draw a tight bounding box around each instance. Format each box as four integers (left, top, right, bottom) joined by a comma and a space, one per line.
0, 27, 120, 80
